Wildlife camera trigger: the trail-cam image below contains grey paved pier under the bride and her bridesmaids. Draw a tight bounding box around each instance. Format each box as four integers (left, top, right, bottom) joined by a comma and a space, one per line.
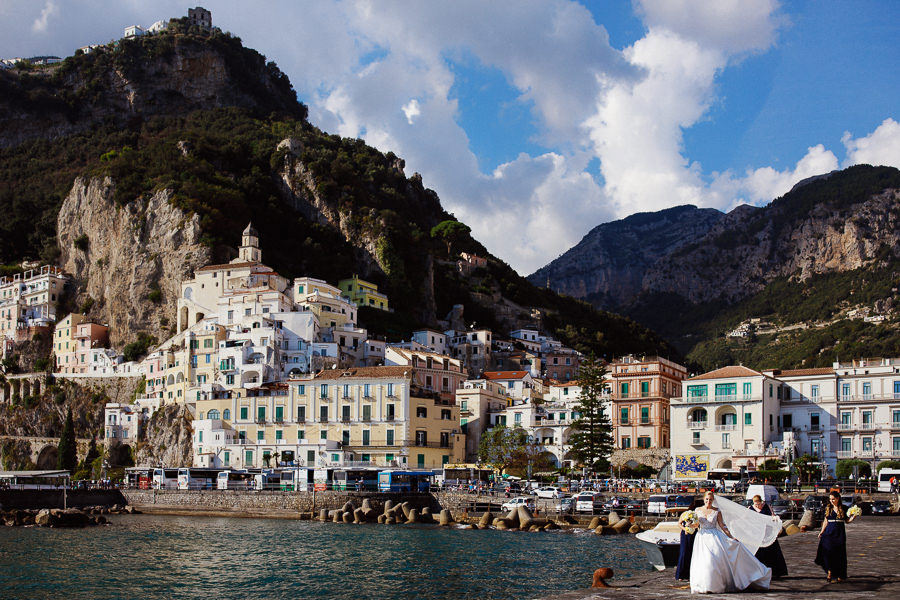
547, 516, 900, 600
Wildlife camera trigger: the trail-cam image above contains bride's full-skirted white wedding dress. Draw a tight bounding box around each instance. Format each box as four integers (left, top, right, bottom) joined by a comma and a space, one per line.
691, 511, 772, 594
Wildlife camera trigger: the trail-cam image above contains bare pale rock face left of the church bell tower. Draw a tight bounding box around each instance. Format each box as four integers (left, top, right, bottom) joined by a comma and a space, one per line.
57, 178, 210, 349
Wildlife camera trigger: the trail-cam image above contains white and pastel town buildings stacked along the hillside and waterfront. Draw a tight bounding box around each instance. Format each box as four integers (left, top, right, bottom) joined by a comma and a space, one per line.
0, 224, 900, 479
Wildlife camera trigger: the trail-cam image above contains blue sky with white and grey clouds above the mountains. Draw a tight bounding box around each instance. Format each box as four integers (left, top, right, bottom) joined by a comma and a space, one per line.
0, 0, 900, 274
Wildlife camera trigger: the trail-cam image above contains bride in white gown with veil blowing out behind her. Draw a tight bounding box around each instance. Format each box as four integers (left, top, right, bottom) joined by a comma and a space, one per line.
691, 491, 780, 594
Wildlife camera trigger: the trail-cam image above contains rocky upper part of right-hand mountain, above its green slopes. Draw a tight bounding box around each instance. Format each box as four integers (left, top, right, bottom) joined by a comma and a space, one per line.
642, 166, 900, 303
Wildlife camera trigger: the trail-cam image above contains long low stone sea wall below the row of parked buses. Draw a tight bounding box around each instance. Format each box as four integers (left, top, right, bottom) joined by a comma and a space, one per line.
122, 490, 440, 516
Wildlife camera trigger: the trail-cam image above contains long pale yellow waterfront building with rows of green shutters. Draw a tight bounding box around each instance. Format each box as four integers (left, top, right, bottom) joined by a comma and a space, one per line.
195, 367, 465, 468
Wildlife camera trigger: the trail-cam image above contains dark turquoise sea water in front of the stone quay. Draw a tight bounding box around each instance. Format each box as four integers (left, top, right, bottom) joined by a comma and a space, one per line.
0, 515, 649, 600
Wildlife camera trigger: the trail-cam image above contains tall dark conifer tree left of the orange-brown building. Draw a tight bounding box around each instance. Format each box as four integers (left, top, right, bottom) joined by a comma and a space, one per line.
569, 354, 613, 472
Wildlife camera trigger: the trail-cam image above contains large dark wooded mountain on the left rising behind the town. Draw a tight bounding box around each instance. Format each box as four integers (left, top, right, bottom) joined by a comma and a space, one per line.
0, 21, 674, 356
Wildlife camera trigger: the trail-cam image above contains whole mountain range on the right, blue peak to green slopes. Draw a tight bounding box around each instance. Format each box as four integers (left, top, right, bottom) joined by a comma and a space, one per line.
530, 165, 900, 368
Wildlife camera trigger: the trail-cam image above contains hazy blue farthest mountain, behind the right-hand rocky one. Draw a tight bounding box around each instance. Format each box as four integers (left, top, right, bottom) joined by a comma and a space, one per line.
528, 205, 725, 308
